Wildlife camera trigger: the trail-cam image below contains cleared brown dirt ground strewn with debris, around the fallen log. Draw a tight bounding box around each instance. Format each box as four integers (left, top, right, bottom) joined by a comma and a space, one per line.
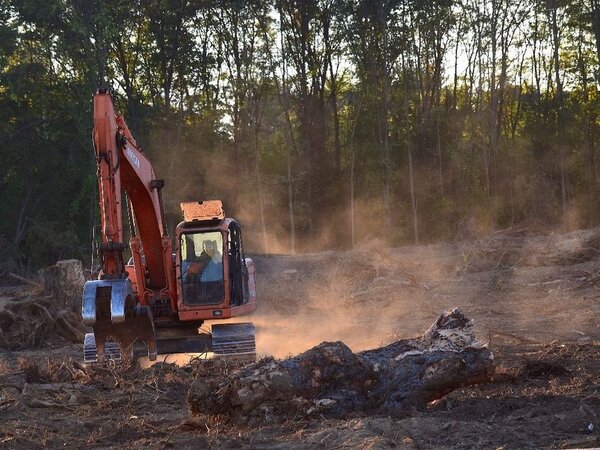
0, 230, 600, 449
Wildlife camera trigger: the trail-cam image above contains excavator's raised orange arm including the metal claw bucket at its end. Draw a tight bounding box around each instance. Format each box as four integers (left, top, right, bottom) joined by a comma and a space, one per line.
82, 91, 177, 359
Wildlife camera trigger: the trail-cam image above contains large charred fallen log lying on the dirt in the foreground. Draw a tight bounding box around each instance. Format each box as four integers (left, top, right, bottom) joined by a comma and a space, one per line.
188, 309, 494, 422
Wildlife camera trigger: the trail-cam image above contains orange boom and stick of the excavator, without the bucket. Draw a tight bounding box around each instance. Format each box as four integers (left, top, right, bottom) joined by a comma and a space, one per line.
94, 91, 170, 289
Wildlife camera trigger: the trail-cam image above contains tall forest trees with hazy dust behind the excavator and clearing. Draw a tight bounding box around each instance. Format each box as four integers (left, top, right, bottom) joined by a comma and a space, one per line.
0, 0, 600, 272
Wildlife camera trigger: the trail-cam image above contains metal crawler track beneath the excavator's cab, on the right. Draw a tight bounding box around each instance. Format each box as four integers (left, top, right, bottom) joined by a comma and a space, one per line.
212, 323, 256, 358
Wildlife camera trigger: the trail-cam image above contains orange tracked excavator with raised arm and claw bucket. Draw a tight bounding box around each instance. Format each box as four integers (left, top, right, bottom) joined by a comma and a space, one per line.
82, 90, 256, 363
